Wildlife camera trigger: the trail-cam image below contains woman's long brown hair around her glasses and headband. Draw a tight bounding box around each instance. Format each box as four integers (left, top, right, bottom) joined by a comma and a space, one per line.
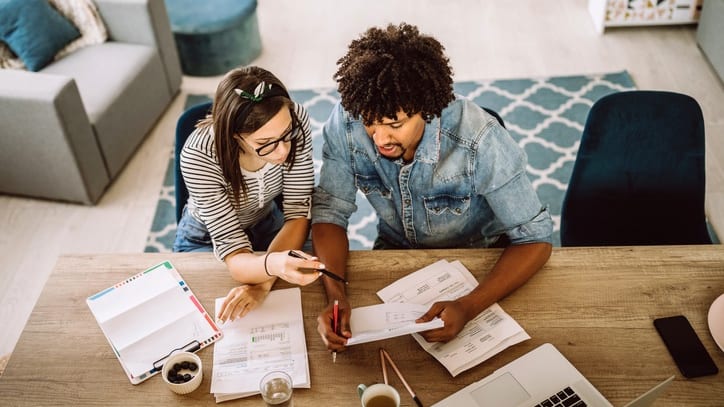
199, 66, 296, 206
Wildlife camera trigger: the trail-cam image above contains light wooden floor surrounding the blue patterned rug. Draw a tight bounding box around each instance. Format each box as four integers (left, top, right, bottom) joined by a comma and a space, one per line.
0, 0, 724, 362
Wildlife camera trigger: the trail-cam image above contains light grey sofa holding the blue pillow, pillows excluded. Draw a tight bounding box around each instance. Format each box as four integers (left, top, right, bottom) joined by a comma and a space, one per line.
0, 0, 181, 204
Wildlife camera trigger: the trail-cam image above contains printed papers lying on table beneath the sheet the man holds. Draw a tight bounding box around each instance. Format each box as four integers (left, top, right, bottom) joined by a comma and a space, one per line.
378, 260, 530, 376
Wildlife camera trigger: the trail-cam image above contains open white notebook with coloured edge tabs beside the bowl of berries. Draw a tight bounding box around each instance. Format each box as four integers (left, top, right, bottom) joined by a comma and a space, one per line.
86, 261, 222, 384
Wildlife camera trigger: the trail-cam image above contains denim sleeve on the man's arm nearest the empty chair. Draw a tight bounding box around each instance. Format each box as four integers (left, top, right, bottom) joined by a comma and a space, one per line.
475, 113, 553, 244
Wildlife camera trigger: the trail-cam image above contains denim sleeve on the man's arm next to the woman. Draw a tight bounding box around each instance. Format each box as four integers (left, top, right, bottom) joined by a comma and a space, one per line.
312, 103, 357, 230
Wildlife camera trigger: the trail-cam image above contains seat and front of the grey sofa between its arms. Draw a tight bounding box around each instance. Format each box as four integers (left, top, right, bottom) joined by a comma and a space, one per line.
43, 41, 172, 178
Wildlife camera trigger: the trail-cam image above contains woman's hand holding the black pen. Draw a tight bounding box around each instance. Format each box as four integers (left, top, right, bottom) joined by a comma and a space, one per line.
264, 250, 324, 285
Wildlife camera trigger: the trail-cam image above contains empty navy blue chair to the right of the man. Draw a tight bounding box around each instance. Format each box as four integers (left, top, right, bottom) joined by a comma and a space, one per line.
561, 91, 712, 246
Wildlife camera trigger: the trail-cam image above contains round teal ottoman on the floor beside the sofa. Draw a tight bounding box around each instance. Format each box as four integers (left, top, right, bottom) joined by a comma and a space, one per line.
165, 0, 261, 76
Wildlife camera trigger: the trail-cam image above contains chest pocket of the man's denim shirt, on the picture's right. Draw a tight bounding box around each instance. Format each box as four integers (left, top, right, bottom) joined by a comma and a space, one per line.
422, 195, 470, 234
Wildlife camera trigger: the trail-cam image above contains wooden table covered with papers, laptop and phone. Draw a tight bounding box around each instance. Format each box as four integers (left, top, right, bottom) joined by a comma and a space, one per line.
0, 245, 724, 407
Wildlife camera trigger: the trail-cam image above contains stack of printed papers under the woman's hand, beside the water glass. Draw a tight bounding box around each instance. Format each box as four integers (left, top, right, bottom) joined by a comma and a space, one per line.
211, 288, 310, 403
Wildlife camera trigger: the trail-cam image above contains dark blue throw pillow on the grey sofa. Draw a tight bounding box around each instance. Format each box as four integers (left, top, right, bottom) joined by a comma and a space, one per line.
0, 0, 80, 72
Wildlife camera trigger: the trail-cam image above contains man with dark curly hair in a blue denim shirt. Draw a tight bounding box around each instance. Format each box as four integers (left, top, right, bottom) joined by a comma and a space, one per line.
312, 23, 552, 352
